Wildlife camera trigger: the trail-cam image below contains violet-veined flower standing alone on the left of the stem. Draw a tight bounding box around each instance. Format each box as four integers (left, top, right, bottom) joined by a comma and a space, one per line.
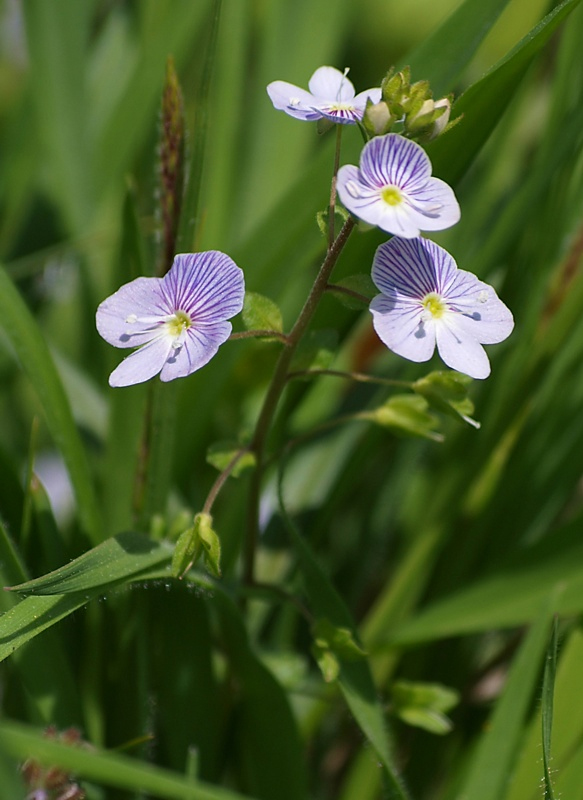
97, 250, 245, 386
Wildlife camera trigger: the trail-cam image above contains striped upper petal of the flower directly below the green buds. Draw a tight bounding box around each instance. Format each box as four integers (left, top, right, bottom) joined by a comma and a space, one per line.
360, 133, 431, 193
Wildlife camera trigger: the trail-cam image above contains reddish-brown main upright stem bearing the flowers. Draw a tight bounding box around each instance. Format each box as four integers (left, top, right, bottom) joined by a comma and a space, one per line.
244, 219, 355, 586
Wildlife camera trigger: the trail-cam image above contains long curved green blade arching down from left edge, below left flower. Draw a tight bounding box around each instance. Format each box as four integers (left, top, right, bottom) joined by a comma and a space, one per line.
0, 267, 102, 544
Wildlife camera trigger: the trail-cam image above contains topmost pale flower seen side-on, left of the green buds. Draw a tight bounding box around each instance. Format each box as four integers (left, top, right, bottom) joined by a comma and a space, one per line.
267, 67, 381, 125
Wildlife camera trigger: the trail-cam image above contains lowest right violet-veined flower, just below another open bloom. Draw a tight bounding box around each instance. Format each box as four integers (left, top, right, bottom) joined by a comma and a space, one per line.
370, 238, 514, 378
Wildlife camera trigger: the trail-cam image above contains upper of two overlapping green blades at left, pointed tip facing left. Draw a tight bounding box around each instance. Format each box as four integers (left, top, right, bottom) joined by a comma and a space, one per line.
8, 532, 172, 592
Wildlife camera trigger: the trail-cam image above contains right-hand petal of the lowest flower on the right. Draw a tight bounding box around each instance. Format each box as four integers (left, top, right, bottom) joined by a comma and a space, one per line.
447, 270, 514, 344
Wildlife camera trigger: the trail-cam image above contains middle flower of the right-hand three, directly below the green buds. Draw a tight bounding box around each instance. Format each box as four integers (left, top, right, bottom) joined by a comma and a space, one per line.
337, 133, 460, 239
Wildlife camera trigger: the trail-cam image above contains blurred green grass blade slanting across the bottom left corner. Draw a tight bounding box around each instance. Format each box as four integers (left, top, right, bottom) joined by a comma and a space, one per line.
0, 721, 253, 800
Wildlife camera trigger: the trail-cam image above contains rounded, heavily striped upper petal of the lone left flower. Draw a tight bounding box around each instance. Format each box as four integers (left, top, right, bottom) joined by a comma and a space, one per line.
164, 250, 245, 324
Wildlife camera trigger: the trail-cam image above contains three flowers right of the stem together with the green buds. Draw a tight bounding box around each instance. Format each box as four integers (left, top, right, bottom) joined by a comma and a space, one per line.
267, 67, 514, 378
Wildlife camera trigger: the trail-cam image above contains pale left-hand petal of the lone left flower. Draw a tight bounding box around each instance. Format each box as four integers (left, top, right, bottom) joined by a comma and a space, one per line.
95, 278, 173, 347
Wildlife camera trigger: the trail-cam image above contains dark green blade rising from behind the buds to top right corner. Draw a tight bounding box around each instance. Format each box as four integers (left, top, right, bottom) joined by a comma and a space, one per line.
427, 0, 580, 184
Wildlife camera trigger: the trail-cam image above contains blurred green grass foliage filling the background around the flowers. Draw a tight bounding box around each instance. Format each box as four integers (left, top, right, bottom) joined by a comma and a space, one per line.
0, 0, 583, 800
